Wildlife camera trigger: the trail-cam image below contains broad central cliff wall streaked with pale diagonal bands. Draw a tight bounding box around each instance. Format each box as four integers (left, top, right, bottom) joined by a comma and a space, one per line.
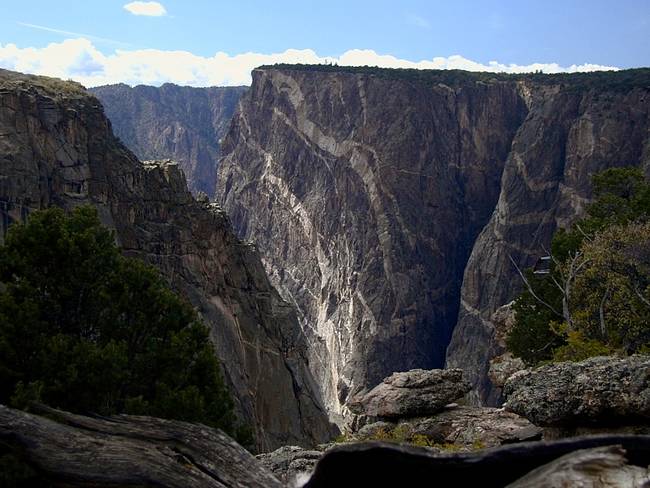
216, 69, 527, 415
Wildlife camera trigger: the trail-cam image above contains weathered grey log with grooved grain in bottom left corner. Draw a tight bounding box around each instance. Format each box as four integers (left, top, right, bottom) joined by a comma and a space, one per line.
0, 405, 282, 488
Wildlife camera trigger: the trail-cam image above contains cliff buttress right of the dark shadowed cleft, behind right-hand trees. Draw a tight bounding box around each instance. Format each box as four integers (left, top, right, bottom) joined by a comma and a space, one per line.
447, 82, 650, 403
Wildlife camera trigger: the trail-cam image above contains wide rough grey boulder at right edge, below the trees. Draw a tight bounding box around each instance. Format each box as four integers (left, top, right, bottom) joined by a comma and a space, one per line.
504, 356, 650, 426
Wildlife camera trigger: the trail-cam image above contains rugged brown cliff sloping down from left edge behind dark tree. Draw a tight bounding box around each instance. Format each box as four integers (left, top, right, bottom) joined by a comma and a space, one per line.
0, 70, 330, 449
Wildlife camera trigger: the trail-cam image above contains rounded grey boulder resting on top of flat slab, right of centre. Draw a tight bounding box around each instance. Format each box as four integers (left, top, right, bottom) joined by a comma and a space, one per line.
350, 369, 470, 419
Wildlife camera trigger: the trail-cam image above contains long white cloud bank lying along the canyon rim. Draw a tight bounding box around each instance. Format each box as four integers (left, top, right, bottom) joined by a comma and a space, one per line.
0, 38, 617, 86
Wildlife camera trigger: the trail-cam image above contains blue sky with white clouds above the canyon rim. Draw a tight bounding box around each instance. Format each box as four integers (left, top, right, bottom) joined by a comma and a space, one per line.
0, 0, 650, 85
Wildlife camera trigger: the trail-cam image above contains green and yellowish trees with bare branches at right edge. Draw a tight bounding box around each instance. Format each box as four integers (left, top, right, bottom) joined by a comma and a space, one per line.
507, 168, 650, 364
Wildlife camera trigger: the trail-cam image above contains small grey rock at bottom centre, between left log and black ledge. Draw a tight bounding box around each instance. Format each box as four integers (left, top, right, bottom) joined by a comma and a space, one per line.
256, 446, 323, 488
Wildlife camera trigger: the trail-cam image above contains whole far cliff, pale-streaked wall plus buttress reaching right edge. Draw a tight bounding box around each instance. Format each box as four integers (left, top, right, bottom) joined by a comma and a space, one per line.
216, 66, 650, 418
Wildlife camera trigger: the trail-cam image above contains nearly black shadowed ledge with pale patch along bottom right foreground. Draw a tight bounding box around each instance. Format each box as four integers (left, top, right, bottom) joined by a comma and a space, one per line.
305, 436, 650, 488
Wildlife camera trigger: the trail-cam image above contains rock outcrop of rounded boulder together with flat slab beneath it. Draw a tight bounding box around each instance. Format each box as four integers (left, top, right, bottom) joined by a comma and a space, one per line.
346, 369, 542, 450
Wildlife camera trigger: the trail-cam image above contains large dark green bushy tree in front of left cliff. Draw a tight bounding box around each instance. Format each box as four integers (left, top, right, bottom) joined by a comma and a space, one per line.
0, 207, 246, 440
